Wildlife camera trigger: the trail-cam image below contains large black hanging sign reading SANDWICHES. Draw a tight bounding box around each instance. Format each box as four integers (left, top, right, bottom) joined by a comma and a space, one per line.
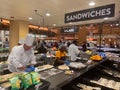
65, 4, 115, 23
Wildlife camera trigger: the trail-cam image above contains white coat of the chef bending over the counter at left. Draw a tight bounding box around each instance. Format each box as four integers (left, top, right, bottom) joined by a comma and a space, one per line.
8, 45, 36, 72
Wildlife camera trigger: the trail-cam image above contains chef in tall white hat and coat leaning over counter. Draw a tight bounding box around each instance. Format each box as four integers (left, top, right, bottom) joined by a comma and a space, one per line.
8, 34, 36, 72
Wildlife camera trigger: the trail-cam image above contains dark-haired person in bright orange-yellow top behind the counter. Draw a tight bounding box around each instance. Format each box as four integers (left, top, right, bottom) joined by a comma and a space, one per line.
54, 46, 66, 67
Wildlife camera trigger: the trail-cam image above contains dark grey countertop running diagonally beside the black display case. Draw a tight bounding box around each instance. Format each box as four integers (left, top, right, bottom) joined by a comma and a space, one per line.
45, 60, 106, 90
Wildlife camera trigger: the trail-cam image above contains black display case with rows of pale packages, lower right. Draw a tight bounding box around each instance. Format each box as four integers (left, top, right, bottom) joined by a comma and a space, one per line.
61, 60, 120, 90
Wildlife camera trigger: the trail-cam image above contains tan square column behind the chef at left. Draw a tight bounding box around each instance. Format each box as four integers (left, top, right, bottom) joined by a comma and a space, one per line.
9, 20, 29, 50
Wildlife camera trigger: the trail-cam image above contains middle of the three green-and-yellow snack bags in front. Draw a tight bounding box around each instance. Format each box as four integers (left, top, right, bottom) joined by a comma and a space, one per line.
19, 73, 32, 90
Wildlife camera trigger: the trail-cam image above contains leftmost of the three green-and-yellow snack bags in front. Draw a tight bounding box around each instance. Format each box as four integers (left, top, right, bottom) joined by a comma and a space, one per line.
9, 76, 21, 90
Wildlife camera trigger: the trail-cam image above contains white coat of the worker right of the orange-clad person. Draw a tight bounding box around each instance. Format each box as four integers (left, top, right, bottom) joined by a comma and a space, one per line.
68, 44, 80, 61
